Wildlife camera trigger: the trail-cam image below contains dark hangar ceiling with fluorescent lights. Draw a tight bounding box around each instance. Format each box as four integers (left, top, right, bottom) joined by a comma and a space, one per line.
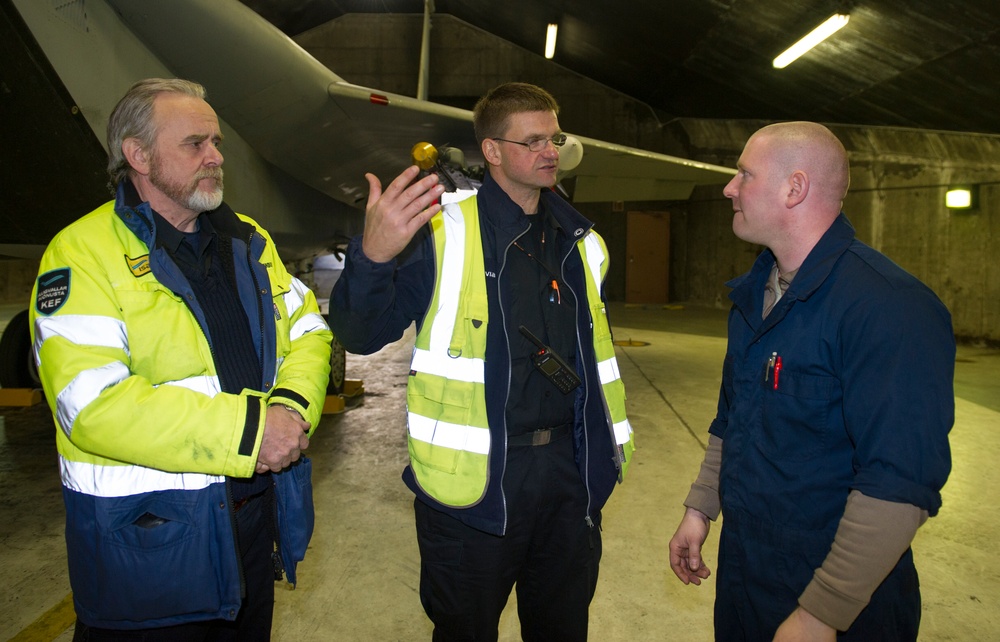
242, 0, 1000, 134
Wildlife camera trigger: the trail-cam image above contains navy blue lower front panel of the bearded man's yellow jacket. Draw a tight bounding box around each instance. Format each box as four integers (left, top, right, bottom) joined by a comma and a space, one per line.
67, 489, 239, 628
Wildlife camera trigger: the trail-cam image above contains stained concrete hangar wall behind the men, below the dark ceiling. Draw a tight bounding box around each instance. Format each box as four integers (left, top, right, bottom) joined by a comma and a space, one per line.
296, 14, 1000, 341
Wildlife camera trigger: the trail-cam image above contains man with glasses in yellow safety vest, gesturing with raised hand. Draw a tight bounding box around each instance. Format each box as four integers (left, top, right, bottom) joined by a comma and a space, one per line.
330, 83, 633, 641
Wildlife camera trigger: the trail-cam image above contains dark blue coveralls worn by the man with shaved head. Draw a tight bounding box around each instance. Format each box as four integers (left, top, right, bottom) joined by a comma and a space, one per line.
710, 214, 955, 640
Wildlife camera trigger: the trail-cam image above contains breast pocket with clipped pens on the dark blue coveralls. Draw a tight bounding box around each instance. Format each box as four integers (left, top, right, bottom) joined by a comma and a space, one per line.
757, 369, 842, 461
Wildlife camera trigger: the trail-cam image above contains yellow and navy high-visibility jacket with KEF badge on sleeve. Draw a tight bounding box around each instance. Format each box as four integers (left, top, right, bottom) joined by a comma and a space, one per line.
31, 184, 332, 628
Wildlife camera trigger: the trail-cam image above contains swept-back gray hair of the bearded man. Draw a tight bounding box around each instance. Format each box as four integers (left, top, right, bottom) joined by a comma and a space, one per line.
108, 78, 206, 194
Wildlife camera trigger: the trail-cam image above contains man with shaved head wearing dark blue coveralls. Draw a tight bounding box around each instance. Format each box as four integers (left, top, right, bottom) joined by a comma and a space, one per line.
670, 122, 955, 642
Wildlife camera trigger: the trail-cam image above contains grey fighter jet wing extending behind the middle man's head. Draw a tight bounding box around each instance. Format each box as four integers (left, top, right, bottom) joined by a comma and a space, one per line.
108, 0, 733, 206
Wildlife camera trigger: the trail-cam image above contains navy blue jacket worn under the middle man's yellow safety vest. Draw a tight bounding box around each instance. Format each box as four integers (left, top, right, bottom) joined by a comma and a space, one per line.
330, 174, 619, 535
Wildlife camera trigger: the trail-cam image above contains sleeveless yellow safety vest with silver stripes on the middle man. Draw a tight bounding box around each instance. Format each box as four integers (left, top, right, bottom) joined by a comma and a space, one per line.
407, 196, 633, 508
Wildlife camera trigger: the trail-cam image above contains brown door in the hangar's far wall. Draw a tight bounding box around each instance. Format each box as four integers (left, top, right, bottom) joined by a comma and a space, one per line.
625, 212, 670, 303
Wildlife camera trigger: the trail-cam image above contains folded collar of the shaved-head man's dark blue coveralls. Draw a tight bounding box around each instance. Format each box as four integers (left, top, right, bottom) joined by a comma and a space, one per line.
726, 213, 854, 323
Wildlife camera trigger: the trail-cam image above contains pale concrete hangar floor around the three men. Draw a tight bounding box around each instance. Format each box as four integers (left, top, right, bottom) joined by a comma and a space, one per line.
0, 305, 1000, 642
